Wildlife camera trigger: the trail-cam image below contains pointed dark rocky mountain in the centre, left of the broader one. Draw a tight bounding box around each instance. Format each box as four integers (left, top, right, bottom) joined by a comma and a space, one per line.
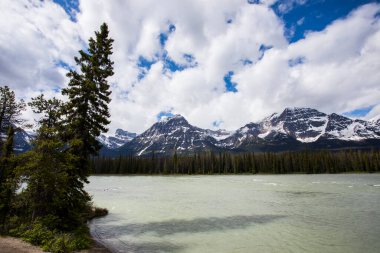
119, 115, 229, 156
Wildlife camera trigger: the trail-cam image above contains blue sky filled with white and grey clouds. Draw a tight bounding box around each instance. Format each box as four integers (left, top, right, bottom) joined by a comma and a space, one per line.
0, 0, 380, 134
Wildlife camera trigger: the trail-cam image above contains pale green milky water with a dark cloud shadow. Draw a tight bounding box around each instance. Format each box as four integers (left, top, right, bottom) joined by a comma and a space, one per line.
86, 174, 380, 253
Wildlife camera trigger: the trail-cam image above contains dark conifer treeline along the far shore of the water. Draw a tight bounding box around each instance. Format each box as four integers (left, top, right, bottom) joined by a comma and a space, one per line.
92, 150, 380, 175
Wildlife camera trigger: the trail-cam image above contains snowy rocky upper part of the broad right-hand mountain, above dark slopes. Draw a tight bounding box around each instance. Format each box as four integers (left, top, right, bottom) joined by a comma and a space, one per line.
219, 108, 380, 149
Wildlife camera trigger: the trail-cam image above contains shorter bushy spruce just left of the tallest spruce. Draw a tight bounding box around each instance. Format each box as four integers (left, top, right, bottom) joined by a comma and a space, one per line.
17, 95, 90, 230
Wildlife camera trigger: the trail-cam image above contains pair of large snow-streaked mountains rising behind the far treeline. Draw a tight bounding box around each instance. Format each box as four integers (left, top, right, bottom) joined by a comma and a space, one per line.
114, 108, 380, 156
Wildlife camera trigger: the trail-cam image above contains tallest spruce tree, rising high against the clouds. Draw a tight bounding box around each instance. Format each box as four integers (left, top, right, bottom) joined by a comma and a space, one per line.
62, 23, 114, 182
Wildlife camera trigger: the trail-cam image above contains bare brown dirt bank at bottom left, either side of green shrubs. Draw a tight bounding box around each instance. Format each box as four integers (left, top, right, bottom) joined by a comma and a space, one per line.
0, 236, 112, 253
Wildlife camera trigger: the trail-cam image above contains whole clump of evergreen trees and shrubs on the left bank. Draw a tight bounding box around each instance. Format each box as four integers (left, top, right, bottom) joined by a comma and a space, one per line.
0, 24, 113, 252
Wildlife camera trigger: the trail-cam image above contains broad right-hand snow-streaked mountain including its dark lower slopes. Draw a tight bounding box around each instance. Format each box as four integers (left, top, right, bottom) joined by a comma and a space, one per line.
219, 108, 380, 151
